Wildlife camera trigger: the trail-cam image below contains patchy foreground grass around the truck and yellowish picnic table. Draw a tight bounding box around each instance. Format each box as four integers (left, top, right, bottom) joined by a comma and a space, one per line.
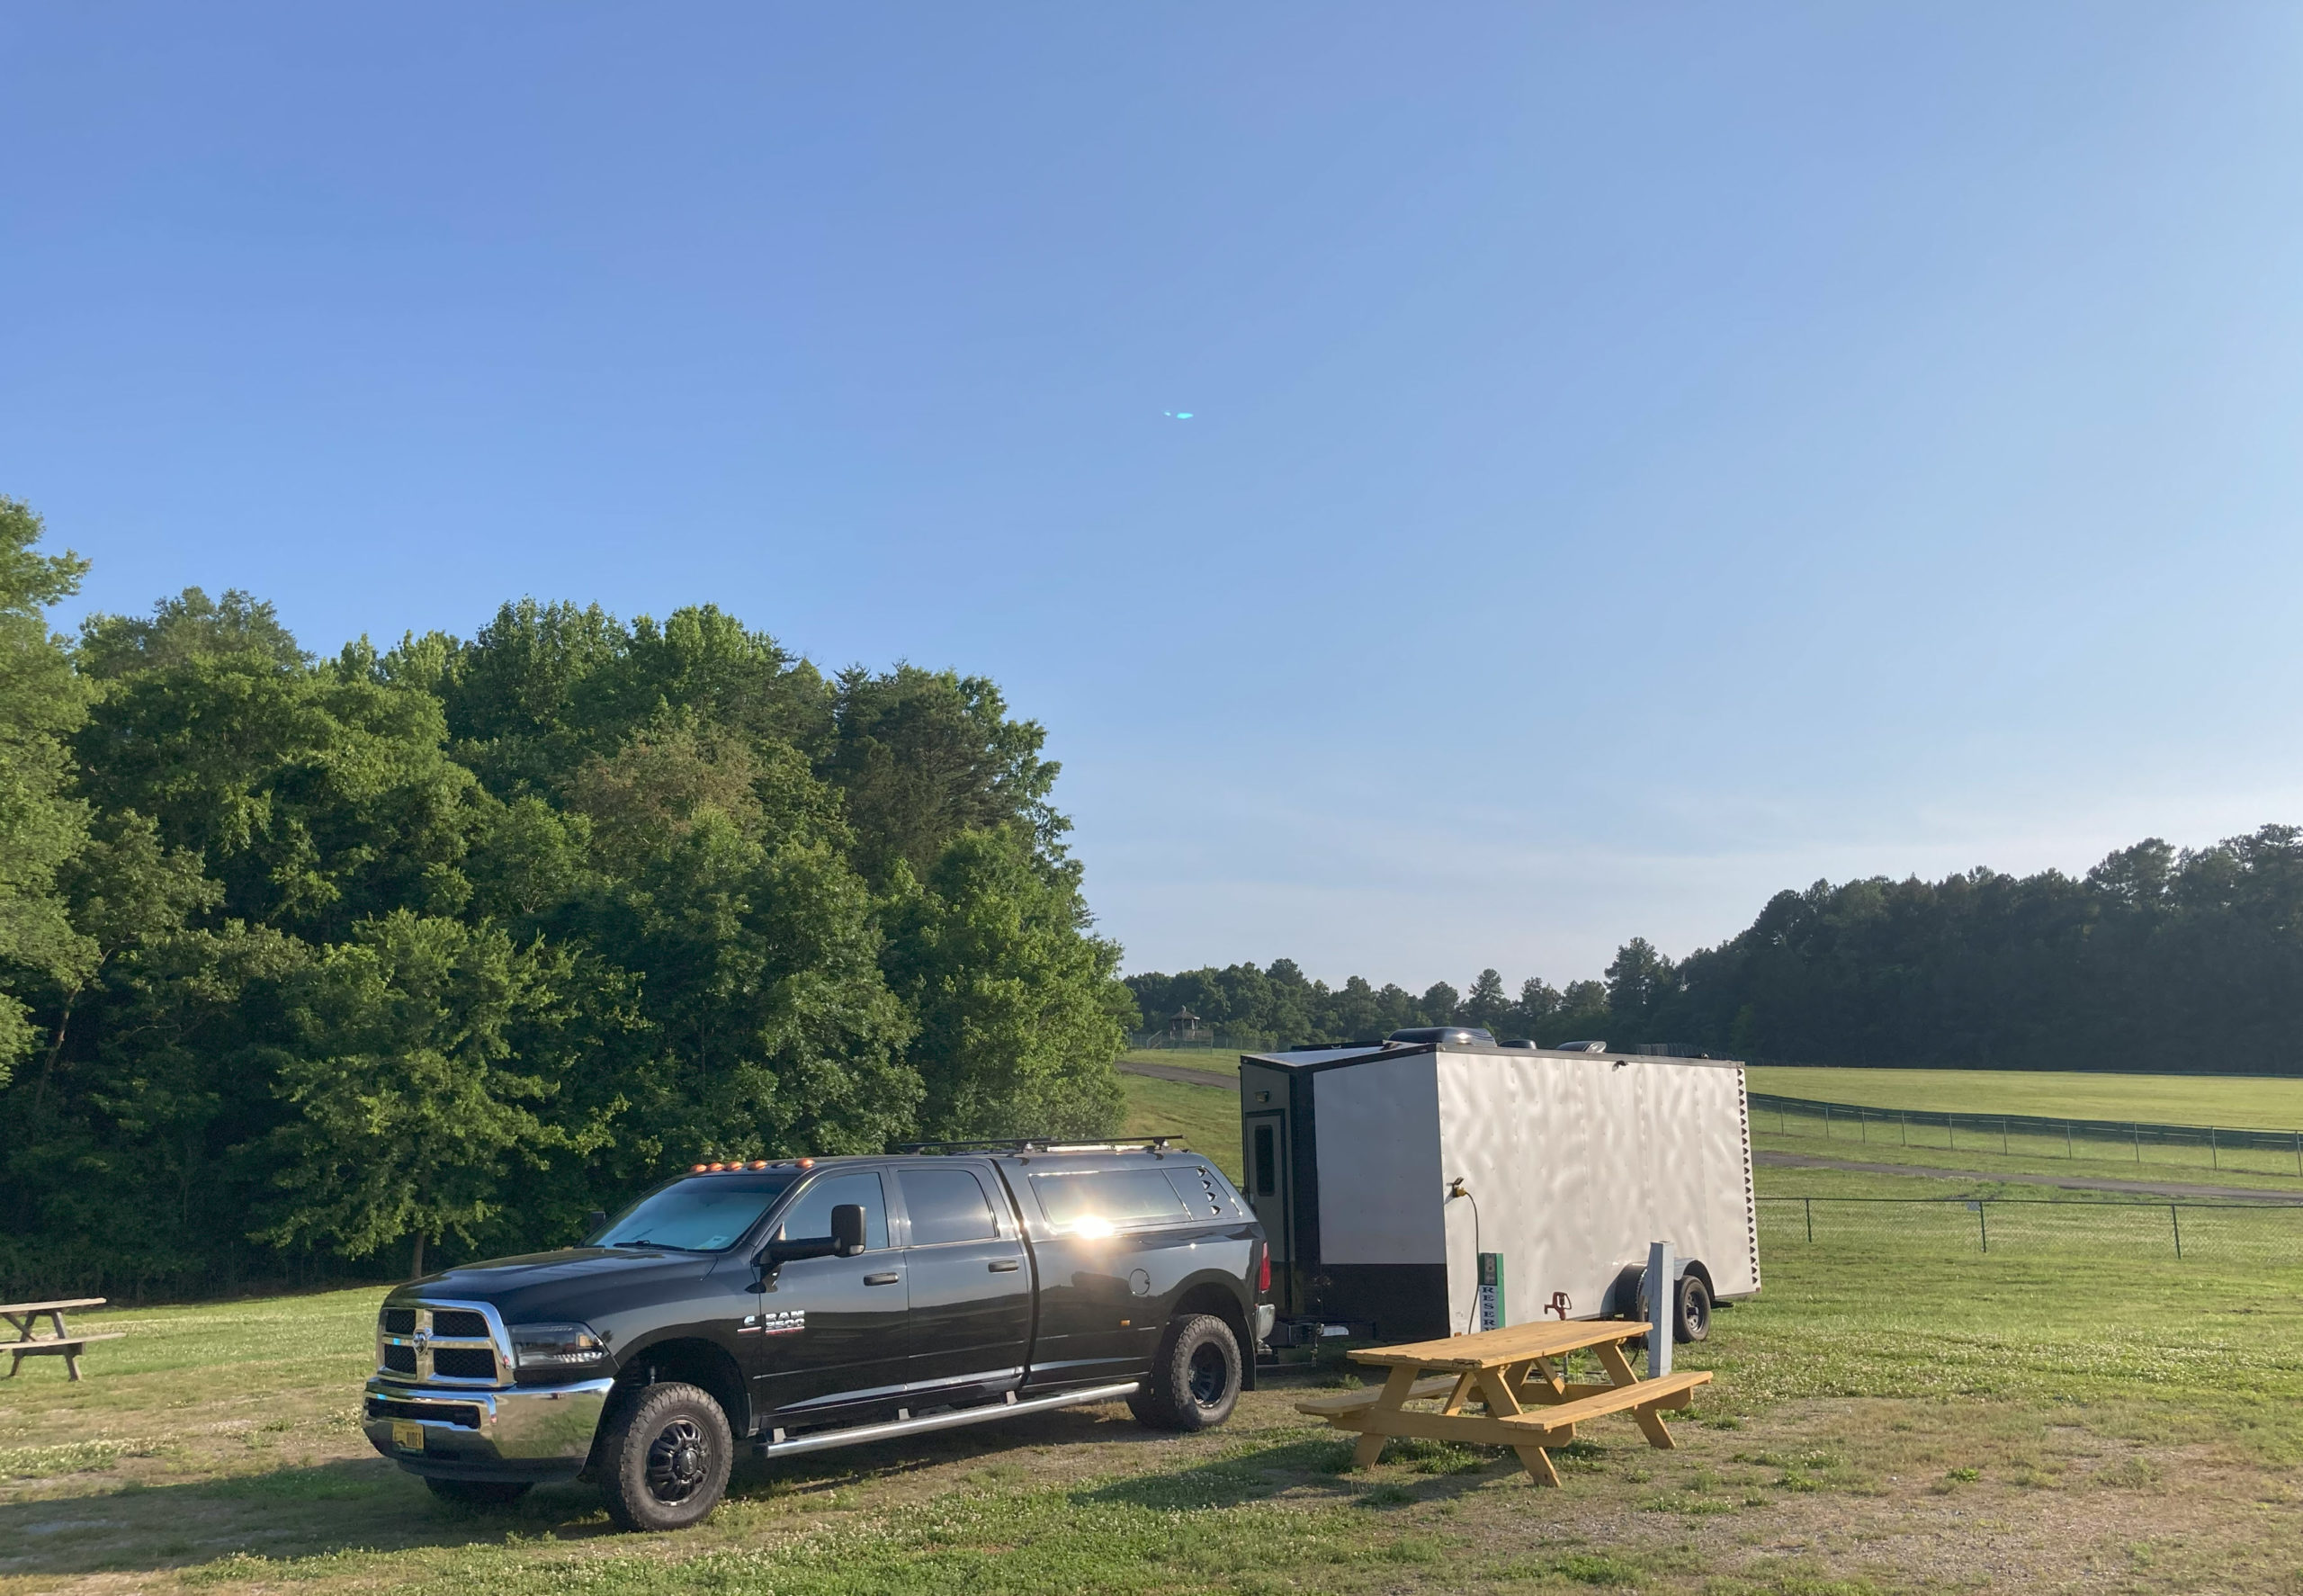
13, 1237, 2303, 1596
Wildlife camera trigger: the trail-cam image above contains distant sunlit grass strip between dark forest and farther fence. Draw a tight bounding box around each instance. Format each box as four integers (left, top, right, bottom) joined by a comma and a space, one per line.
1745, 1066, 2303, 1131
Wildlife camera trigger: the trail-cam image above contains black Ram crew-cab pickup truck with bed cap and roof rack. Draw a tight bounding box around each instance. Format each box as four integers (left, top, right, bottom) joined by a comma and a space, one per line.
363, 1143, 1271, 1529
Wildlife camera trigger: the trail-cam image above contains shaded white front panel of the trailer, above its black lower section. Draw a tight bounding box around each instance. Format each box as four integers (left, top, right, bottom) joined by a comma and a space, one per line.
1317, 1053, 1447, 1264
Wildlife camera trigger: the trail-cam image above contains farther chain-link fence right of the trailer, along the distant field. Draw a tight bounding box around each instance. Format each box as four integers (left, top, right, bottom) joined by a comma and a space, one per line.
1751, 1091, 2303, 1179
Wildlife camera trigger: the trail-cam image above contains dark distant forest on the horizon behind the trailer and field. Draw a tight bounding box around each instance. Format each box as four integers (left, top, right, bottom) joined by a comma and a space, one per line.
1128, 824, 2303, 1073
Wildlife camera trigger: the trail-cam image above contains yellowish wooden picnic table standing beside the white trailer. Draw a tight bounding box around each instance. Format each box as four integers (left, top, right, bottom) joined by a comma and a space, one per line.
1296, 1320, 1711, 1485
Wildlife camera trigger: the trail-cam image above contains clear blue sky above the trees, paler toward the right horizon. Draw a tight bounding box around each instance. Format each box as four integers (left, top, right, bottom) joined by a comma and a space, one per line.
0, 0, 2303, 986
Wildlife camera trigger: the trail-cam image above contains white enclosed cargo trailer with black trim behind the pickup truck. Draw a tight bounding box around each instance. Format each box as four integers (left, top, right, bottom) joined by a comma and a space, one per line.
1239, 1041, 1760, 1340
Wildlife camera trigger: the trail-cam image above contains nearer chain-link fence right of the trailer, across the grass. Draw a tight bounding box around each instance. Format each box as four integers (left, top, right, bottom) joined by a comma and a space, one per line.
1757, 1197, 2303, 1267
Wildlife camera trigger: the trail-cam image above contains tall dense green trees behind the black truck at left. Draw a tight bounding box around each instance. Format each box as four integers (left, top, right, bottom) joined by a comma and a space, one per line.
0, 499, 1135, 1292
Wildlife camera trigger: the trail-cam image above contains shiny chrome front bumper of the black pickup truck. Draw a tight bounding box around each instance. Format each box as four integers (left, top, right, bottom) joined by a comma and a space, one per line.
362, 1375, 615, 1481
